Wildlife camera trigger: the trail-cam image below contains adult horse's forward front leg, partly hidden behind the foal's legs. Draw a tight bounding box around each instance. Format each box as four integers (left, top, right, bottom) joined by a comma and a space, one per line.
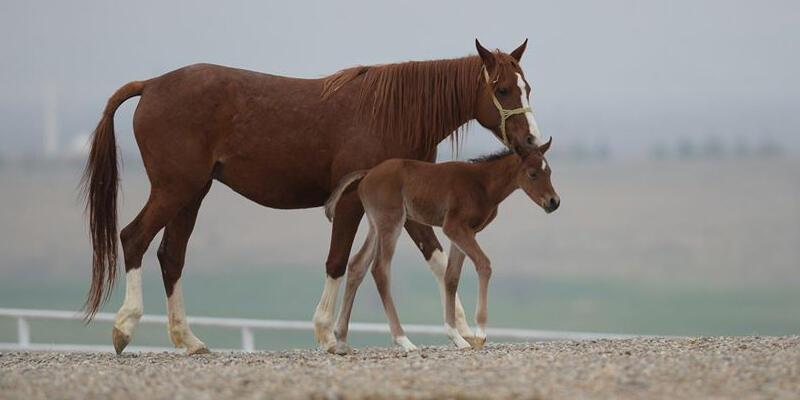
406, 220, 473, 341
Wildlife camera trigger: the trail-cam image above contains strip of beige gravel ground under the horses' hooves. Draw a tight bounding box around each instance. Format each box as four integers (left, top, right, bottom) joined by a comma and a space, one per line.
0, 336, 800, 400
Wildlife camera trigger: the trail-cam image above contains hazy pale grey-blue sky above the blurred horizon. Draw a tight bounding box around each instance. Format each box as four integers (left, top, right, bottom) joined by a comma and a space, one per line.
0, 0, 800, 154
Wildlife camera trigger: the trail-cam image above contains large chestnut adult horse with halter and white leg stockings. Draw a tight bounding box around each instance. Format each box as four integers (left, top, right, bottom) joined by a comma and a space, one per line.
84, 40, 543, 354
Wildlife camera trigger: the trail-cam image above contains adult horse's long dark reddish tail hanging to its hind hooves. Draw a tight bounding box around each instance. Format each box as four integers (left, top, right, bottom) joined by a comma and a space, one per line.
81, 81, 144, 322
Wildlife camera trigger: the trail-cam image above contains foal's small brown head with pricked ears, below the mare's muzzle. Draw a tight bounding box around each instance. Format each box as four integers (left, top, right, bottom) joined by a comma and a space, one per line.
517, 138, 561, 214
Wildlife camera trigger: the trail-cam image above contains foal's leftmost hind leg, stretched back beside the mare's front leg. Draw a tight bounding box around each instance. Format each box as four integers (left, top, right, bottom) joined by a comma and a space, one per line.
334, 225, 375, 355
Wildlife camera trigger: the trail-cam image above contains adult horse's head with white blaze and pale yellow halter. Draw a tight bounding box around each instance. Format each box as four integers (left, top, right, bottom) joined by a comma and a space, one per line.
475, 39, 544, 158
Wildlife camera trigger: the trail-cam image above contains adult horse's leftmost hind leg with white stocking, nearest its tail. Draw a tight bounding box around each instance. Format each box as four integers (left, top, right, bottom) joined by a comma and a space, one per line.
112, 185, 199, 354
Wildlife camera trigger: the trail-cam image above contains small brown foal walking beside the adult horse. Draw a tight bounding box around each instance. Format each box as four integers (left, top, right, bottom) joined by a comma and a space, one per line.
325, 139, 560, 354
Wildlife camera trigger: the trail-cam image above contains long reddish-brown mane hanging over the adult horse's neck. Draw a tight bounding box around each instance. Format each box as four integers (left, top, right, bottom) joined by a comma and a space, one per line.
322, 56, 483, 148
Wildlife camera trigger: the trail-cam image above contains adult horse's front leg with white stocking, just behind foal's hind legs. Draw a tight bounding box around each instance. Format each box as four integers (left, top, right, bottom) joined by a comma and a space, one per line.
314, 191, 364, 353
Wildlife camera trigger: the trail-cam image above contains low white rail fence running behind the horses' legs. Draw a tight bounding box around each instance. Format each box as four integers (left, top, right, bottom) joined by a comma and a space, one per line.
0, 308, 638, 352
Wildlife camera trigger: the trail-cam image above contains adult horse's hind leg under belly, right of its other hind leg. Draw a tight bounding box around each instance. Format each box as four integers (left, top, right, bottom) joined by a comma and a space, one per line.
157, 181, 211, 354
